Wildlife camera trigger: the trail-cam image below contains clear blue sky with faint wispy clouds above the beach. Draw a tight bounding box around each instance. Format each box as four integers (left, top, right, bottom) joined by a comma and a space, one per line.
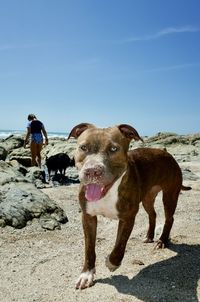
0, 0, 200, 135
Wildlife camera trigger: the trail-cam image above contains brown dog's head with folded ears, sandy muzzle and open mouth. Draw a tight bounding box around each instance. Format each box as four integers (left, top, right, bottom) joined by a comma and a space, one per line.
68, 123, 142, 201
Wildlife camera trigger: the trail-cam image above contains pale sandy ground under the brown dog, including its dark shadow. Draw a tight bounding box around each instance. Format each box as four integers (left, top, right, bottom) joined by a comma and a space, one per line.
0, 179, 200, 302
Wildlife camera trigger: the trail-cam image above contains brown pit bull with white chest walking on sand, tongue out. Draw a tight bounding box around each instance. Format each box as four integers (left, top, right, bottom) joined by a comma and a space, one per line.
68, 123, 191, 289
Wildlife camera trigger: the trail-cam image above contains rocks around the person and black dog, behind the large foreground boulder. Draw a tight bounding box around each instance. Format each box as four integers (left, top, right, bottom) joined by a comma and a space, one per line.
0, 135, 78, 188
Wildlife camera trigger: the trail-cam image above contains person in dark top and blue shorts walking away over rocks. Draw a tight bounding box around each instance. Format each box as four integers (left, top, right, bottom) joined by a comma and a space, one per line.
24, 114, 48, 168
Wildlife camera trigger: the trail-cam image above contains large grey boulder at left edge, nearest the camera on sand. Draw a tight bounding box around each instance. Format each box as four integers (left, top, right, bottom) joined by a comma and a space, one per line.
0, 161, 68, 230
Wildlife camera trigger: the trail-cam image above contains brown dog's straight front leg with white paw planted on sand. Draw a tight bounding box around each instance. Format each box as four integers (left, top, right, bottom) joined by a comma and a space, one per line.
76, 213, 97, 289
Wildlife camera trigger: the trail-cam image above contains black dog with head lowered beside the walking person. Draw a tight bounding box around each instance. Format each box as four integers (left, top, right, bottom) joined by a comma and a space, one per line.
46, 153, 75, 180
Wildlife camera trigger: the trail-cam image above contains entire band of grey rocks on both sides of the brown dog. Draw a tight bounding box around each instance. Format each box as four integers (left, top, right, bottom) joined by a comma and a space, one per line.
0, 133, 200, 229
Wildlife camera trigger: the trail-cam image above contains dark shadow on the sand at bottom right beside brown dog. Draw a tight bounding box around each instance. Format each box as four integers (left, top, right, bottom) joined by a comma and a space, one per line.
96, 243, 200, 302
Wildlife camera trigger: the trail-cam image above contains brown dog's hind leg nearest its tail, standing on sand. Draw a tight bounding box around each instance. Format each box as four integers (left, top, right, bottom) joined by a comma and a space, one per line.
155, 190, 180, 249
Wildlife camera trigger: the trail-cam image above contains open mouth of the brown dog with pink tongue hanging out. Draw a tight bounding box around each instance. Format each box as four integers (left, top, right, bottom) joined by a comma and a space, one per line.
85, 182, 113, 201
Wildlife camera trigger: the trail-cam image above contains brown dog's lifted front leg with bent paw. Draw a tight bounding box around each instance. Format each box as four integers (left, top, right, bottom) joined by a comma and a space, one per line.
106, 218, 135, 272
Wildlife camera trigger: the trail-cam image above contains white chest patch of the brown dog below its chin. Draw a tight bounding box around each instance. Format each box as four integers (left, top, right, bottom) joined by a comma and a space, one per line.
86, 175, 123, 219
